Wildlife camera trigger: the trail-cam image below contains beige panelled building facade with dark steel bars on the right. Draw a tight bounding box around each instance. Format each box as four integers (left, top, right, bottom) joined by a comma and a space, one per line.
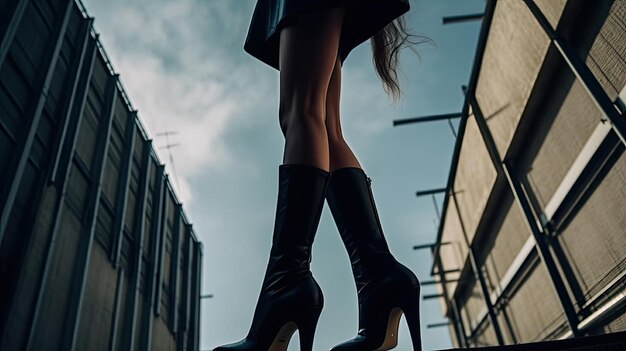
432, 0, 626, 347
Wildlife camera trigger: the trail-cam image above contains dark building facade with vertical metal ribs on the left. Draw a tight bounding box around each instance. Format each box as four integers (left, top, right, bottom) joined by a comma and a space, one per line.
0, 0, 202, 350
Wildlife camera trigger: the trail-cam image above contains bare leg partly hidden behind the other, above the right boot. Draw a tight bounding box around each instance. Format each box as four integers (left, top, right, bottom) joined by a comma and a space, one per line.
326, 57, 361, 172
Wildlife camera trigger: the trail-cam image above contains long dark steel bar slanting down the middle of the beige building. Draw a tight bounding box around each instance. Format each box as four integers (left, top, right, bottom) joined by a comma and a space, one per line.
469, 95, 580, 336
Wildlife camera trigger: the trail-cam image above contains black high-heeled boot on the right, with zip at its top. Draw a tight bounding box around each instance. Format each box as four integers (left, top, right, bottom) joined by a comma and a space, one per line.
326, 167, 421, 351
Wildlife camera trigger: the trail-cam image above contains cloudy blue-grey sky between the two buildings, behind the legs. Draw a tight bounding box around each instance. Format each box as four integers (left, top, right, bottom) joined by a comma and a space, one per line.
83, 0, 485, 351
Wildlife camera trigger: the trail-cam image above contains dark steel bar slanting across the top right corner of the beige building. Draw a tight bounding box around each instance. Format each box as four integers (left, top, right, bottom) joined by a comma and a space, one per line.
524, 0, 626, 145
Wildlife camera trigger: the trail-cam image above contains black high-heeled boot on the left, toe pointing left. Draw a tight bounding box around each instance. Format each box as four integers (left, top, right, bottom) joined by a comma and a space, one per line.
213, 165, 328, 351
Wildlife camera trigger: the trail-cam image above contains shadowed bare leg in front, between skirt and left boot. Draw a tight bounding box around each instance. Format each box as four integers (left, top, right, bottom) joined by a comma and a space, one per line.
279, 5, 345, 171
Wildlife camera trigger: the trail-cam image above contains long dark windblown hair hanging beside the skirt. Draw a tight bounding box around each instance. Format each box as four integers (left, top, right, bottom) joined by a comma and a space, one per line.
371, 16, 434, 103
